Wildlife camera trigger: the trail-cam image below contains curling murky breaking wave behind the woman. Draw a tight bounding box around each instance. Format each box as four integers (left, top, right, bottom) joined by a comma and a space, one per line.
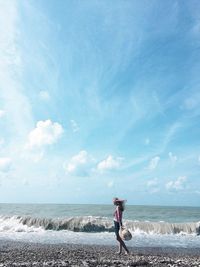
0, 216, 200, 235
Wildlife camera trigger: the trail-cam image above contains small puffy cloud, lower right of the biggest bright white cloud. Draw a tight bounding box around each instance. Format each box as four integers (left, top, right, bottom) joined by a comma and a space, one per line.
63, 150, 94, 176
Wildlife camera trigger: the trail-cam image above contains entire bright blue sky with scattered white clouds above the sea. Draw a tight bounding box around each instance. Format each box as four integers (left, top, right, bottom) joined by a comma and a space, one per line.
0, 0, 200, 206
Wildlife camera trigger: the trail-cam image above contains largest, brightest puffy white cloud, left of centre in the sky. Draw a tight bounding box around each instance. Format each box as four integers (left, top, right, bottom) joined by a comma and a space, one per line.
28, 120, 63, 148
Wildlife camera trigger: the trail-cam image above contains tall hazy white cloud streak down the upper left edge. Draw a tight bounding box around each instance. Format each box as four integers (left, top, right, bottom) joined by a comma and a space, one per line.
0, 1, 32, 142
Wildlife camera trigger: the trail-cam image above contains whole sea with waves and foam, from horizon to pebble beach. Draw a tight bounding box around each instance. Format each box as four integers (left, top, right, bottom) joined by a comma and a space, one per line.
0, 204, 200, 249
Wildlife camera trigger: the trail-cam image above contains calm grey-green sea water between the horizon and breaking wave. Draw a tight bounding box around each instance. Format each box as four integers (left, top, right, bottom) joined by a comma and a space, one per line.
0, 204, 200, 223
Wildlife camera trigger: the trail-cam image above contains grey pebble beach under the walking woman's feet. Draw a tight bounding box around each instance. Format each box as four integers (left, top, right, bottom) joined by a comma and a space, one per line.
0, 241, 200, 267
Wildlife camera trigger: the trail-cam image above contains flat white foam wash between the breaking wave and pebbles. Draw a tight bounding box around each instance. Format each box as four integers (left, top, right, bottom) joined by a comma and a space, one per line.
0, 230, 200, 249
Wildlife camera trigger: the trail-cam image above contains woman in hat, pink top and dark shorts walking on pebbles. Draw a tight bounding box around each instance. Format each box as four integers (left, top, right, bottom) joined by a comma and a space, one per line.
113, 197, 129, 254
